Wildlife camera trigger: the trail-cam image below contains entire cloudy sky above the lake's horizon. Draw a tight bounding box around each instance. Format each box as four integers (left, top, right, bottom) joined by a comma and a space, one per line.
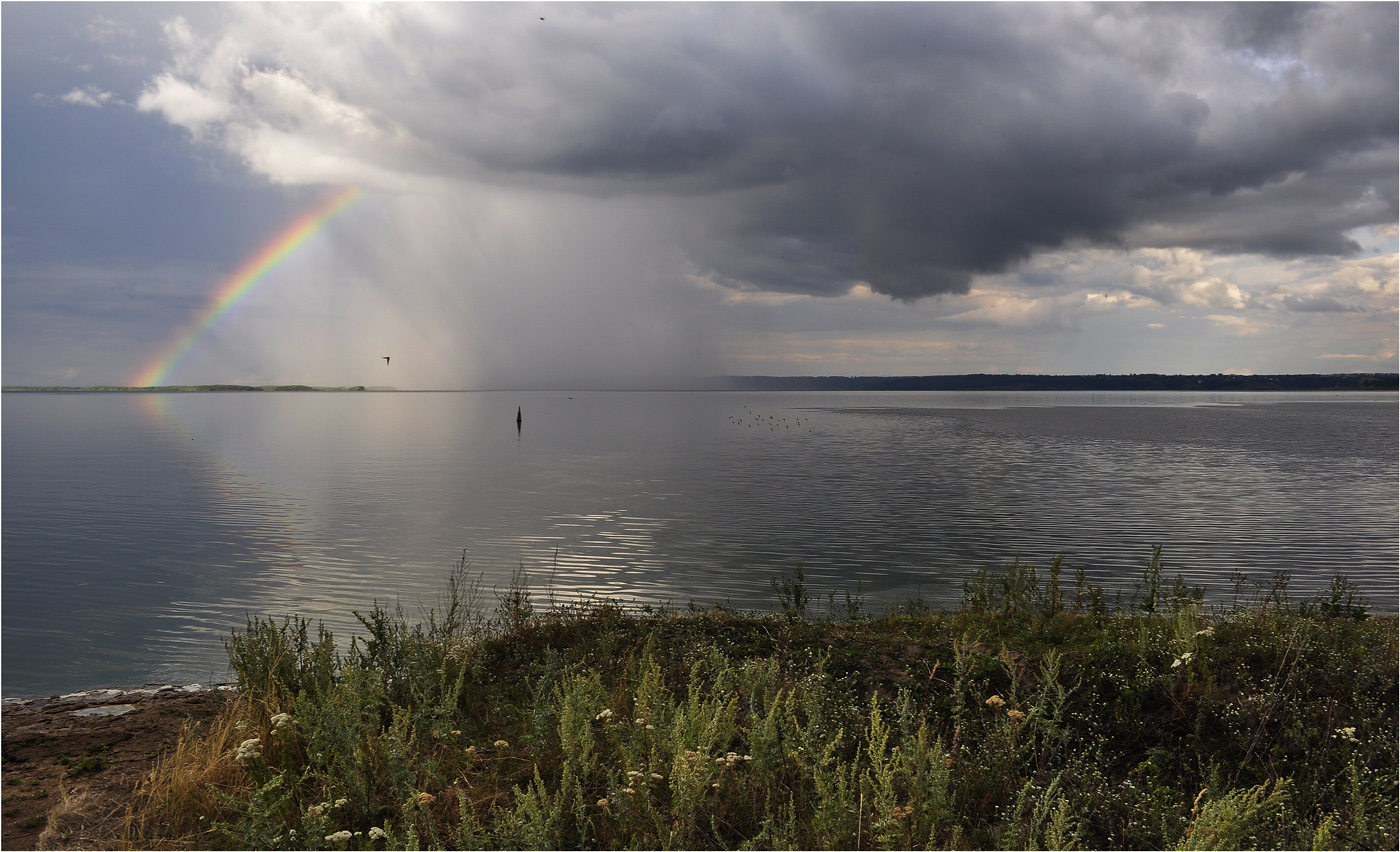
0, 0, 1400, 389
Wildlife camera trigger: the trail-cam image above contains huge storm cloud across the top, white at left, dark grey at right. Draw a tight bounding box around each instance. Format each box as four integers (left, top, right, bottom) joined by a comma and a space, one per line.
128, 4, 1400, 300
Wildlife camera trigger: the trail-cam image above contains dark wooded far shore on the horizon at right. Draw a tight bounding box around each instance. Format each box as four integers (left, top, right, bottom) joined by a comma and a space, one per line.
727, 372, 1400, 390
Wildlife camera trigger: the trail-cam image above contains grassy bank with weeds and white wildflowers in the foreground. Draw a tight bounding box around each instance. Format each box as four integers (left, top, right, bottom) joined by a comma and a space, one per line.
103, 557, 1400, 849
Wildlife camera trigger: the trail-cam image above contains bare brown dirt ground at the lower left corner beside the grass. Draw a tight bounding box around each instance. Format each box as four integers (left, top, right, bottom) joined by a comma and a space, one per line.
0, 687, 232, 849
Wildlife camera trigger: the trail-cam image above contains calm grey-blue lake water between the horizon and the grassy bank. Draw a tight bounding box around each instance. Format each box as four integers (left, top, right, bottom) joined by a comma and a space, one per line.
3, 392, 1397, 697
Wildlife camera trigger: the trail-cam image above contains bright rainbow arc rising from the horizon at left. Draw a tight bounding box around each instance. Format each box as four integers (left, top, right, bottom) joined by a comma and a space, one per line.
132, 186, 364, 388
